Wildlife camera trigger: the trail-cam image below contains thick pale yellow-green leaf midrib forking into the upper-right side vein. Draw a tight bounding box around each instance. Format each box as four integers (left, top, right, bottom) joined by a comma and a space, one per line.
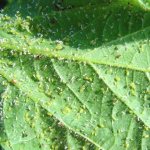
0, 27, 150, 72
